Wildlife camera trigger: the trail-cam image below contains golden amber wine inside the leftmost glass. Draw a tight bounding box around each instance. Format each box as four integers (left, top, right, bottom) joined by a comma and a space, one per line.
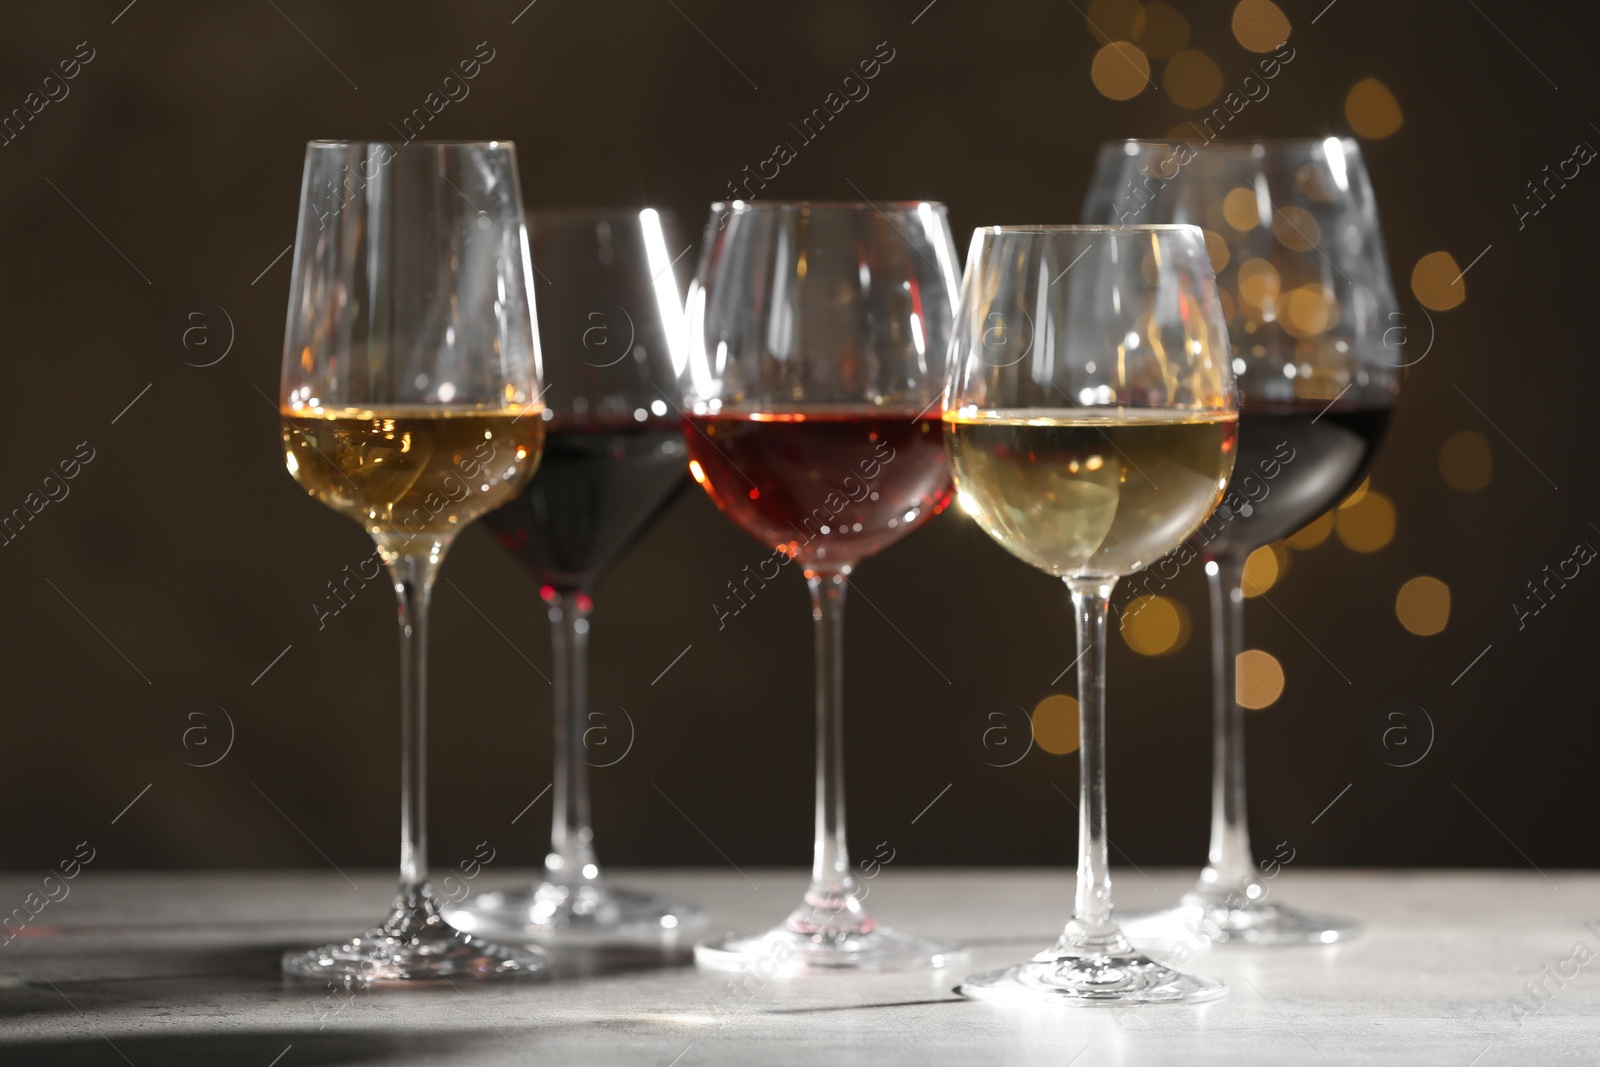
282, 406, 544, 550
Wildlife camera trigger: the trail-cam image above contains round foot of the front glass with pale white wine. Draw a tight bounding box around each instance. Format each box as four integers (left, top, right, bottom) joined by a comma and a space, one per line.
955, 950, 1227, 1005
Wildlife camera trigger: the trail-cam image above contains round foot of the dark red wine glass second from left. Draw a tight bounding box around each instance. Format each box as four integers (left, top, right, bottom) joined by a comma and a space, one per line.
443, 881, 706, 945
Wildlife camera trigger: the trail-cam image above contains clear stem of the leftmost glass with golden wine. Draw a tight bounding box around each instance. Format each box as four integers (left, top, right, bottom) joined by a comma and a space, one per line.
395, 542, 445, 909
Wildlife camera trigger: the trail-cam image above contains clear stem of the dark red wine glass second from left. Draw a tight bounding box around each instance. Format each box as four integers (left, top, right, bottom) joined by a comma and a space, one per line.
544, 590, 600, 885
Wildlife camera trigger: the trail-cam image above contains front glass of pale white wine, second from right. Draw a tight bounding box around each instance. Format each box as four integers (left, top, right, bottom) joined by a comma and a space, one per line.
944, 226, 1237, 1003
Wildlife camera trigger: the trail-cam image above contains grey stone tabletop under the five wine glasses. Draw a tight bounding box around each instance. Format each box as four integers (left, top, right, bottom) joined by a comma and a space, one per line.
0, 867, 1600, 1067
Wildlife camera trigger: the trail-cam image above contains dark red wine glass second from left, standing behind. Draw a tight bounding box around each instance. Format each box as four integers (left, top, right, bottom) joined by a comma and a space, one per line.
445, 208, 704, 942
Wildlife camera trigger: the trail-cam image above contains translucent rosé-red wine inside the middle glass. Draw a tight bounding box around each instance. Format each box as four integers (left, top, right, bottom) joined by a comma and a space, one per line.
685, 405, 950, 565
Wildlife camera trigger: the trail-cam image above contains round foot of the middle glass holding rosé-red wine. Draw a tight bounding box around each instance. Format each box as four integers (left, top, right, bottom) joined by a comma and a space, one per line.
694, 926, 966, 977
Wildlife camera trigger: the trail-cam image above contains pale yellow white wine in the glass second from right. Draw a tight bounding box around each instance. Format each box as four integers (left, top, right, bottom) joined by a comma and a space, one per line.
944, 408, 1238, 577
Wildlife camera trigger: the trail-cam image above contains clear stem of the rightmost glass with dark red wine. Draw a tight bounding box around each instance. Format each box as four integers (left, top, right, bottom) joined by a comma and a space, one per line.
1197, 555, 1256, 901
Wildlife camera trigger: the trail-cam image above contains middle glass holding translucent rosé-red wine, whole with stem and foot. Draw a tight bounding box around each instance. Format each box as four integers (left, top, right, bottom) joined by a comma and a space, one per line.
685, 202, 957, 974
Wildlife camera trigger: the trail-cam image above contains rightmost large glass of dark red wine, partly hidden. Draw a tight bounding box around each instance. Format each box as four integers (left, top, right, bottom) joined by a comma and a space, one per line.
1085, 138, 1408, 944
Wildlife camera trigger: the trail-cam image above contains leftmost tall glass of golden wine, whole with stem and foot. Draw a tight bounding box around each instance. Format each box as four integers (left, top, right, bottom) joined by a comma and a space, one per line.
280, 141, 544, 979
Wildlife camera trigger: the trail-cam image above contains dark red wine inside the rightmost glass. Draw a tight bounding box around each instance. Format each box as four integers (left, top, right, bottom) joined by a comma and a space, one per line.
1190, 402, 1390, 557
